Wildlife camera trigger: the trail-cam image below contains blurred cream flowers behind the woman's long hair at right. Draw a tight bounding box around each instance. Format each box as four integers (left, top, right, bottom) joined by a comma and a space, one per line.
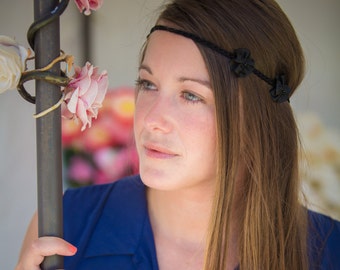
297, 113, 340, 220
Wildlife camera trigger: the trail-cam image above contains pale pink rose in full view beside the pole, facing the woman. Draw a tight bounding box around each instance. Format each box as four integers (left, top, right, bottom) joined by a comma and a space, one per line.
63, 62, 108, 131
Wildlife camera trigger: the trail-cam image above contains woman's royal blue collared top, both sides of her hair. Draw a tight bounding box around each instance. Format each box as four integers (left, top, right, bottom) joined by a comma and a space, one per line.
64, 176, 340, 270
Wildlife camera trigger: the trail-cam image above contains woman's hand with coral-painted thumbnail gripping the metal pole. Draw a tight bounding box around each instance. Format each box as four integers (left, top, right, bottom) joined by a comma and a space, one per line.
15, 236, 77, 270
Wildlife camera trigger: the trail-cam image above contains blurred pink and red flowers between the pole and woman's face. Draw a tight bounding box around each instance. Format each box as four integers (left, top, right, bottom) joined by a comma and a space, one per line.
62, 87, 138, 186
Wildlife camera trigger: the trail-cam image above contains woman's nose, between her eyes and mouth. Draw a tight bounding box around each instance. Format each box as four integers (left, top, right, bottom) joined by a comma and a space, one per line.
144, 95, 174, 133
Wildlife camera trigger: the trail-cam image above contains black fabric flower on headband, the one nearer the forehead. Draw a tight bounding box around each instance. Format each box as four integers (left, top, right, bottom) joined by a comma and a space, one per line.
231, 48, 255, 77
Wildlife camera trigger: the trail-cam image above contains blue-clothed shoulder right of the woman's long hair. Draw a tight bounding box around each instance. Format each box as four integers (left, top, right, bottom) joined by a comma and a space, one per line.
308, 211, 340, 269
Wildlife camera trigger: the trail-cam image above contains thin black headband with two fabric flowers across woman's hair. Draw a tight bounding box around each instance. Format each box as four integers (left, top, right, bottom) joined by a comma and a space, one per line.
148, 25, 291, 103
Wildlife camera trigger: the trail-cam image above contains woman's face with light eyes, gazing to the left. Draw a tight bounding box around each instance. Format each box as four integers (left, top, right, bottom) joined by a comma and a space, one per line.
134, 31, 217, 190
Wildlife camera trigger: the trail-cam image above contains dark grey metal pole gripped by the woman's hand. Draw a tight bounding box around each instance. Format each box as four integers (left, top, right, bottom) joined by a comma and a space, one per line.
34, 0, 64, 270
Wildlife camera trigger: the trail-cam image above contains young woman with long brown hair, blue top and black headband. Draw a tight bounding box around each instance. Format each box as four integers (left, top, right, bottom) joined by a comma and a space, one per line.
17, 0, 340, 270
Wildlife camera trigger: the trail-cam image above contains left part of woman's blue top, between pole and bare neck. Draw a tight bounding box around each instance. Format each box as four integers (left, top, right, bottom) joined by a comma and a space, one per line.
64, 176, 155, 269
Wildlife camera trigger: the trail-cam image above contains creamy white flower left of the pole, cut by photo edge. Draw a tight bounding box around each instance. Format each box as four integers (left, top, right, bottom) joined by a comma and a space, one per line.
0, 35, 30, 94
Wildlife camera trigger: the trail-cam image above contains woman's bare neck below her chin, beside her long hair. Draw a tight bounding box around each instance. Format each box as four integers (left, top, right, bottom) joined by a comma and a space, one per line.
147, 182, 213, 247
